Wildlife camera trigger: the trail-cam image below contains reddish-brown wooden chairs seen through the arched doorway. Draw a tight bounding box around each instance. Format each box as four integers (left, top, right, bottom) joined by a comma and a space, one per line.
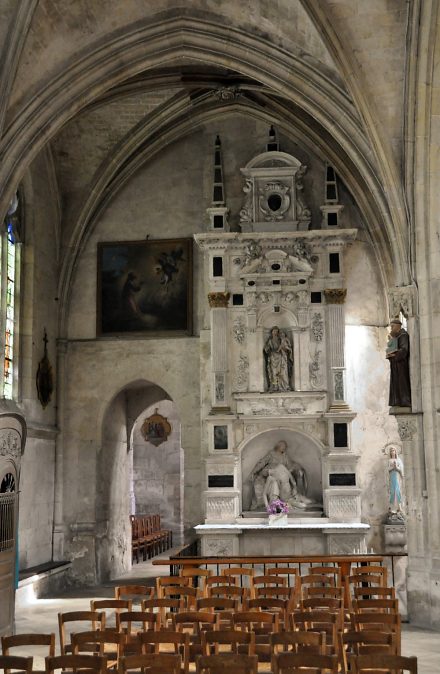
130, 515, 173, 562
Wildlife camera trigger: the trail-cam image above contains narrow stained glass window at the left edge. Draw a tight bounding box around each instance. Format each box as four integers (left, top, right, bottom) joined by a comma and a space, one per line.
0, 194, 20, 399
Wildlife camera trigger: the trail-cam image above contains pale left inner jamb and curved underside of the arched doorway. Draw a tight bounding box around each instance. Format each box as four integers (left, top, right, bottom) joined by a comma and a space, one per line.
95, 380, 180, 581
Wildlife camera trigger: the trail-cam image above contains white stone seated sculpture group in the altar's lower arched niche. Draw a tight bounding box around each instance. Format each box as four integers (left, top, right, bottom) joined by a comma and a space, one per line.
250, 440, 314, 510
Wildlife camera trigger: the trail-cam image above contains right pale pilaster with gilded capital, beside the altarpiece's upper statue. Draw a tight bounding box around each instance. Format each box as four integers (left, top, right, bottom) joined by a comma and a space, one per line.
324, 288, 348, 410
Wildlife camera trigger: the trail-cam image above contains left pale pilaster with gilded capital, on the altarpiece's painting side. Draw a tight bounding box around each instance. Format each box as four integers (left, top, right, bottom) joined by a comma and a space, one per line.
208, 292, 229, 410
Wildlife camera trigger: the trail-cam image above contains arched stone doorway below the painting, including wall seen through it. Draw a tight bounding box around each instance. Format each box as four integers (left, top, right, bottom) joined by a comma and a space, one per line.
96, 380, 183, 581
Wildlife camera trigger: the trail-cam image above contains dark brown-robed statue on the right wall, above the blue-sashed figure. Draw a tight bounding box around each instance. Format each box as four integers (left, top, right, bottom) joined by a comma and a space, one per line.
386, 318, 411, 407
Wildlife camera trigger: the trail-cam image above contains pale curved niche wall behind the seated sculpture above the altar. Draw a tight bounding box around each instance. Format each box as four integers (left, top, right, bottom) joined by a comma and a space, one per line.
239, 427, 322, 511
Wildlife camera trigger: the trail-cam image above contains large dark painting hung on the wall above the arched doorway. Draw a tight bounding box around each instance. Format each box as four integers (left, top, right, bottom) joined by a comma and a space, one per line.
97, 239, 192, 336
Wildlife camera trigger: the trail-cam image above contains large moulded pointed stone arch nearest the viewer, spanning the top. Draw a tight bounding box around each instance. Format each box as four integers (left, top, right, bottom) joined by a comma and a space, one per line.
0, 17, 408, 285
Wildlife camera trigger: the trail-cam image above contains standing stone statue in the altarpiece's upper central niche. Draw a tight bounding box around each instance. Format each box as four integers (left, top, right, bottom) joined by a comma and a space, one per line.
264, 325, 293, 393
